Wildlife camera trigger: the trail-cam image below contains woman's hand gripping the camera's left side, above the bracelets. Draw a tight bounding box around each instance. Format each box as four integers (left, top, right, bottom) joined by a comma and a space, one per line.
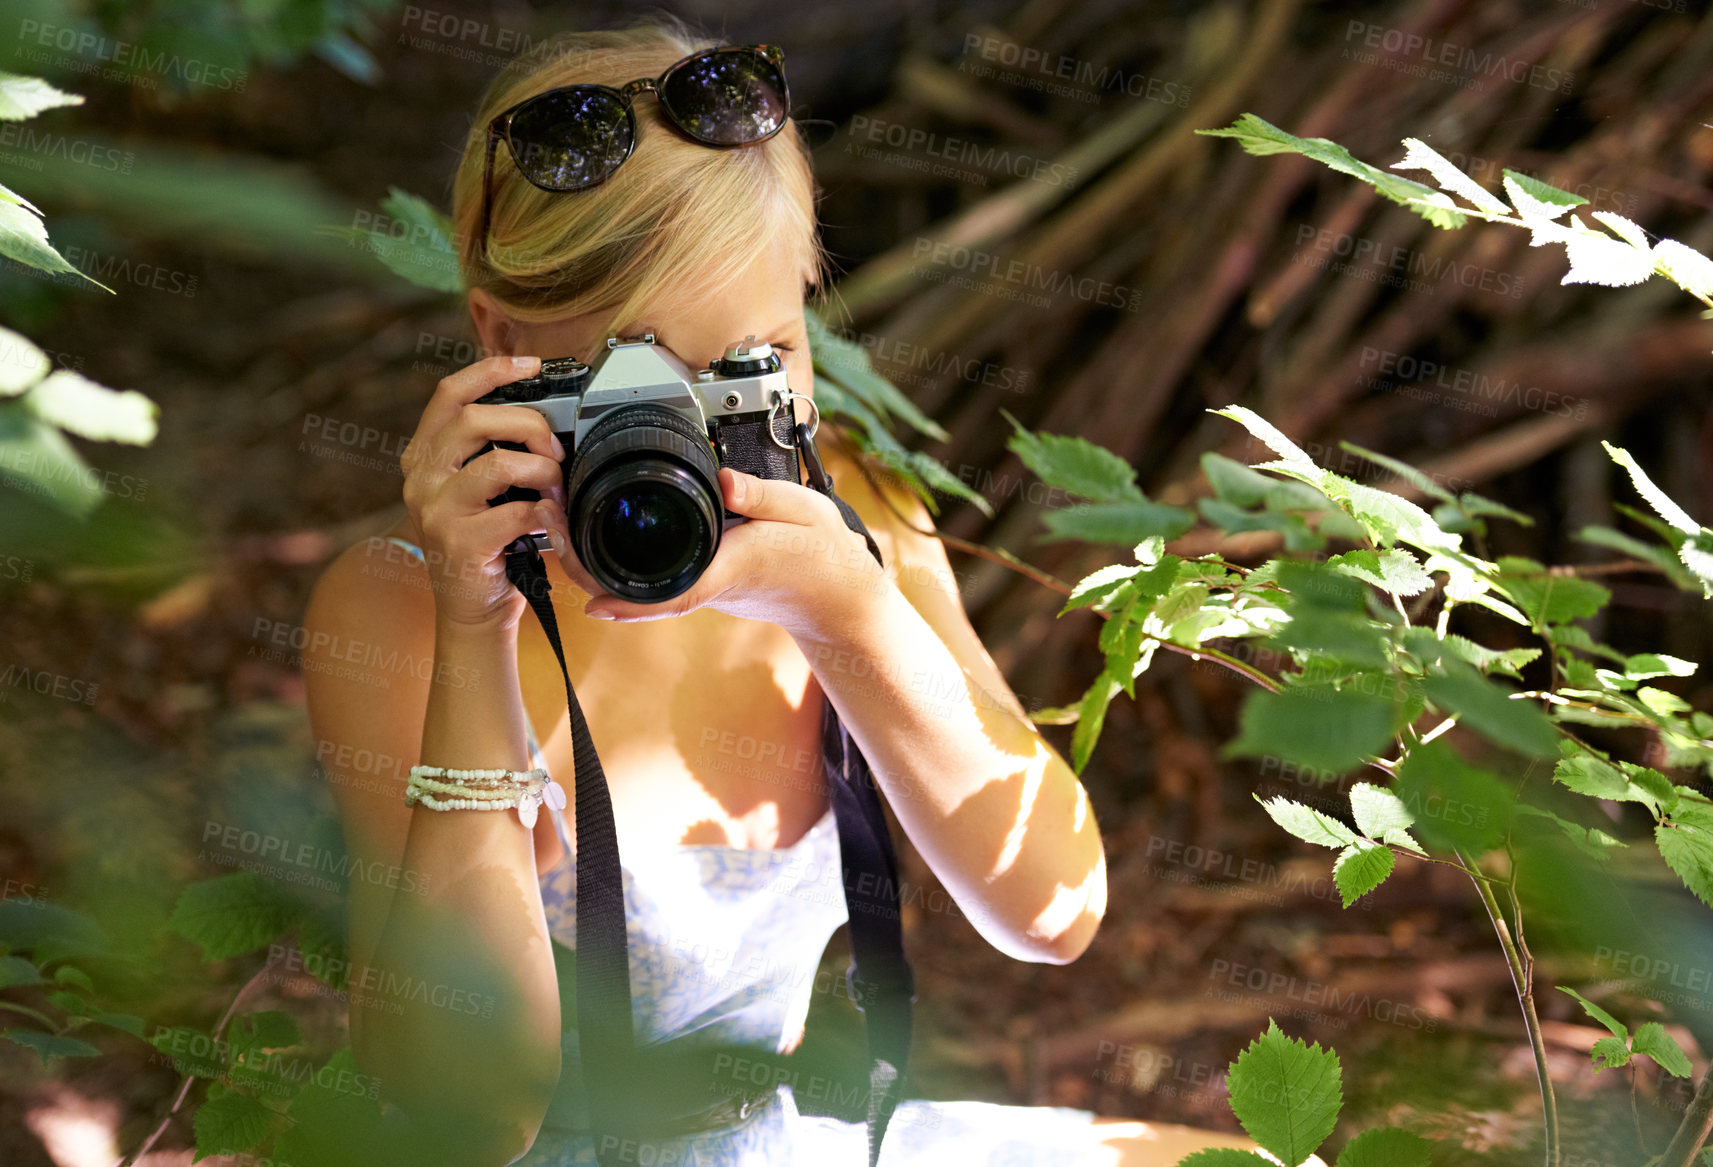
399, 356, 565, 629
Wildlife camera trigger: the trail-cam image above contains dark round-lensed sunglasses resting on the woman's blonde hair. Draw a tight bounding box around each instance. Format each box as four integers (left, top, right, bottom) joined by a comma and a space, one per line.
481, 45, 791, 257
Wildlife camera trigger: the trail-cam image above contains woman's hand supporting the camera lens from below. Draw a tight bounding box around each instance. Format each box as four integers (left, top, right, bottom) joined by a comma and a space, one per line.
543, 466, 892, 634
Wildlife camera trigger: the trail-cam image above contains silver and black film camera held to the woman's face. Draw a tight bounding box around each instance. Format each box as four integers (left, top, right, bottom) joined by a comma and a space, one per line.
476, 334, 798, 603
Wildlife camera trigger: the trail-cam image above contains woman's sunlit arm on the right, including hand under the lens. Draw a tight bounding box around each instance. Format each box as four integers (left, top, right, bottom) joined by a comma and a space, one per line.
575, 470, 1107, 963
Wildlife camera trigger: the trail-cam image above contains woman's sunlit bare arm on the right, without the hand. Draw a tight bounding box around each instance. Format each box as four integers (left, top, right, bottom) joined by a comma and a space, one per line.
797, 462, 1107, 963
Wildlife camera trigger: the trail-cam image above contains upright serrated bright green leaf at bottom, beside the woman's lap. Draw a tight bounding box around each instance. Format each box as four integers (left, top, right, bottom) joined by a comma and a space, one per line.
1227, 1018, 1345, 1164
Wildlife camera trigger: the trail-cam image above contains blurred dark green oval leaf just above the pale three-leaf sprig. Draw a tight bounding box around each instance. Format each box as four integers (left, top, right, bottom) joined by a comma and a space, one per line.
1223, 684, 1396, 775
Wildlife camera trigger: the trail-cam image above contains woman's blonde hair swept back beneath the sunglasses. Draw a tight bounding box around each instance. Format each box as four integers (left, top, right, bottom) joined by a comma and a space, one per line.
452, 17, 826, 332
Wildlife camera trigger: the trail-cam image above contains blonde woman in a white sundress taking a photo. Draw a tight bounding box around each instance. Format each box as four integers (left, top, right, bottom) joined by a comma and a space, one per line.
305, 24, 1288, 1165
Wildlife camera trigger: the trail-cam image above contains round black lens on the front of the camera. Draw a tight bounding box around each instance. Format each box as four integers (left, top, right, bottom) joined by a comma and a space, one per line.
565, 406, 723, 603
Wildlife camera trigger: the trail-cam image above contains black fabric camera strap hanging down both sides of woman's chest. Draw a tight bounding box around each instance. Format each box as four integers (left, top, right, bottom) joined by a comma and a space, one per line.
505, 422, 915, 1167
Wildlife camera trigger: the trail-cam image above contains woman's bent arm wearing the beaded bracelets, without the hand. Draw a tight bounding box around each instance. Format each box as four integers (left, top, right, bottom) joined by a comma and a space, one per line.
303, 540, 560, 1165
